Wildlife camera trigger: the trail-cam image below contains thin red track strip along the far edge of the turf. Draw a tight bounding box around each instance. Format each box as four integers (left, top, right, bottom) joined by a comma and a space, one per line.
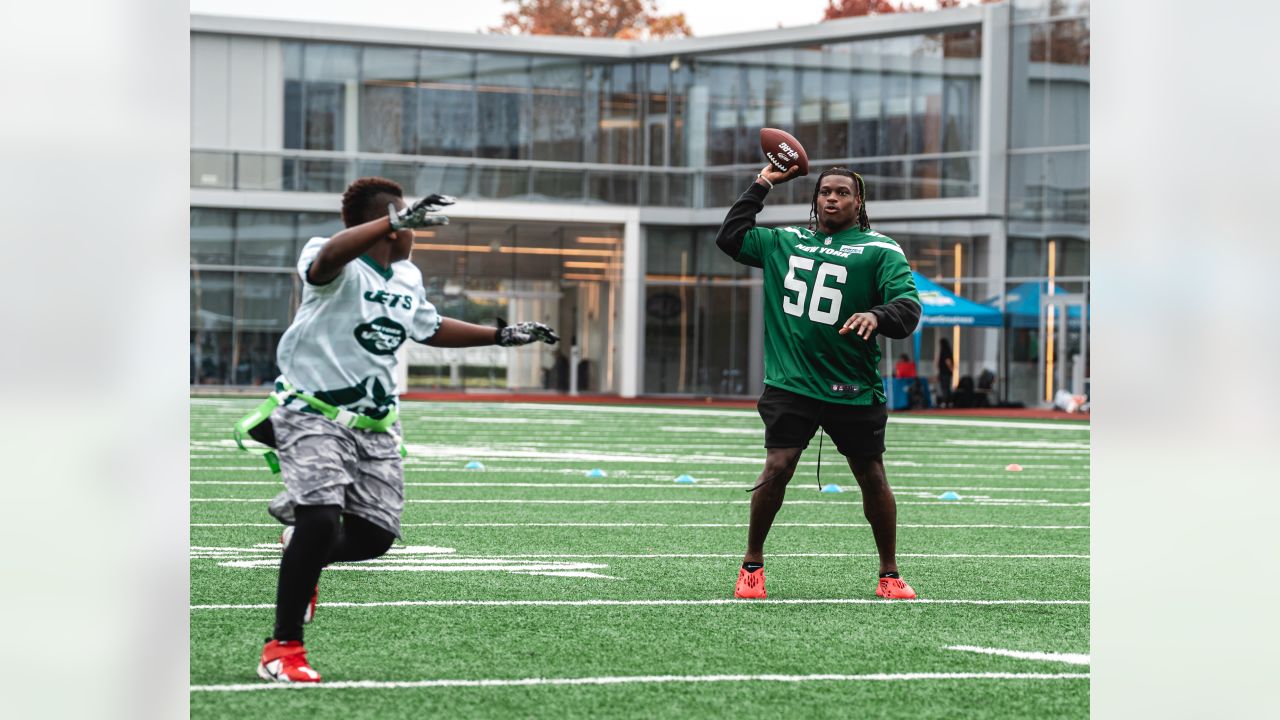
401, 392, 1089, 421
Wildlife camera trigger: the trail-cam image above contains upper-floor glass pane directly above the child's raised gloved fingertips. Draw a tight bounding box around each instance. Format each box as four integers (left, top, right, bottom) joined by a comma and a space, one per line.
417, 50, 477, 158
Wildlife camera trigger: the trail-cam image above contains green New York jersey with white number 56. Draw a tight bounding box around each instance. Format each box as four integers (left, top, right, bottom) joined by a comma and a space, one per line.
736, 227, 920, 405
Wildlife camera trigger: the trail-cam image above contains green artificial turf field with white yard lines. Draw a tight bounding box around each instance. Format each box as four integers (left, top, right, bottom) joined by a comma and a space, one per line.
191, 398, 1089, 720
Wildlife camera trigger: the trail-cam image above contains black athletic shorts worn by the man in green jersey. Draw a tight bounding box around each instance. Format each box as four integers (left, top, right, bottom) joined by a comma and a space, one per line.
755, 386, 888, 457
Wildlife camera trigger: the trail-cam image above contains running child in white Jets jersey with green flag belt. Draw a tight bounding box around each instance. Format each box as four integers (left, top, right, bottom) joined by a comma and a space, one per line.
252, 178, 559, 683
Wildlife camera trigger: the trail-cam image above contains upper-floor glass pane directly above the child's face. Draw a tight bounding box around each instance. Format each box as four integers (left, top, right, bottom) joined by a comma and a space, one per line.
360, 47, 419, 155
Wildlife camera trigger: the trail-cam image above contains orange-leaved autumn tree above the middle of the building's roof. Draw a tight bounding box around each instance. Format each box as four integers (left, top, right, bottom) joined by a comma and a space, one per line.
490, 0, 694, 40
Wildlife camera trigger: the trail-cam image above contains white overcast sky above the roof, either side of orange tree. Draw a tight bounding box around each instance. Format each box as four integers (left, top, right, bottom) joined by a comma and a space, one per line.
191, 0, 952, 36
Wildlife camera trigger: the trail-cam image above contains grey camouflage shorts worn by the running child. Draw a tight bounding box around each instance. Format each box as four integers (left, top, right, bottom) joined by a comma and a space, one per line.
268, 407, 404, 537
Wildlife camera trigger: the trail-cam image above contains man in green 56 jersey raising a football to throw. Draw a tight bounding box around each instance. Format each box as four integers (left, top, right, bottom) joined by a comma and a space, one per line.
716, 167, 920, 600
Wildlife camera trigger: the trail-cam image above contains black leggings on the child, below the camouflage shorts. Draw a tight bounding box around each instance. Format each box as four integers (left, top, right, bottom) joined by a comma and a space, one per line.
274, 505, 396, 641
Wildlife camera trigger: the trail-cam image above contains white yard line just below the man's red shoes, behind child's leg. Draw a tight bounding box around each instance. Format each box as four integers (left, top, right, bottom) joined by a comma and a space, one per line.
191, 597, 1089, 610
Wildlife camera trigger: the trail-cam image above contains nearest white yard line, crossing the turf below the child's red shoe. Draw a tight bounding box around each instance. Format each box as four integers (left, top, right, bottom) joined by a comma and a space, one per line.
191, 673, 1089, 693
